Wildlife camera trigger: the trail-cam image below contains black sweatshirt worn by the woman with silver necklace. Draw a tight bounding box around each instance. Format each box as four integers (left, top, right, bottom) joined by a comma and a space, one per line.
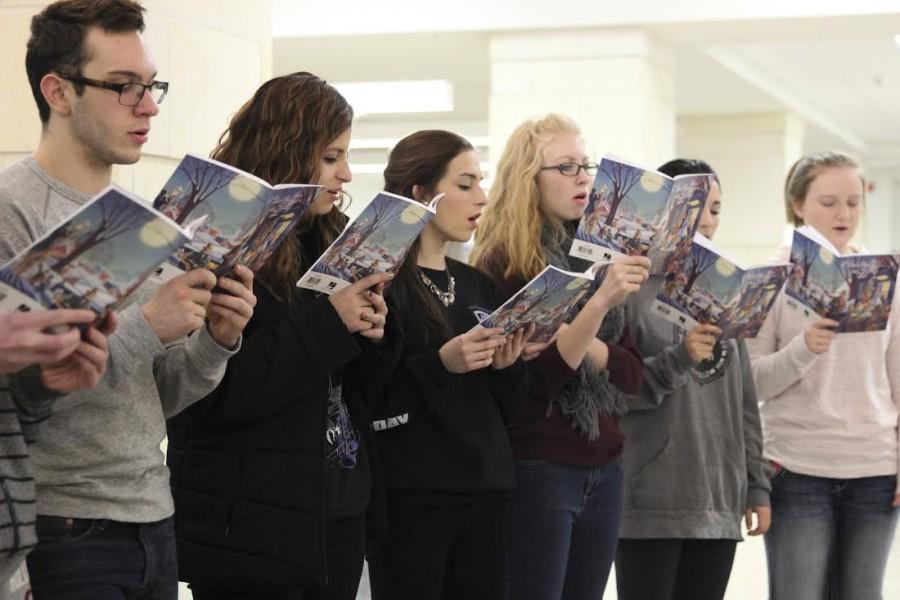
372, 260, 527, 503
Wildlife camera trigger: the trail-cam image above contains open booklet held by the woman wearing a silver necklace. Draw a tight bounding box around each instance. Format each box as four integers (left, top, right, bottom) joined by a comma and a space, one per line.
476, 263, 608, 342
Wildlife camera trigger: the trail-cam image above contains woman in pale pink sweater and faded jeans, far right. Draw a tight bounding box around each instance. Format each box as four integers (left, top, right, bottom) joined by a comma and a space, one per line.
747, 152, 900, 600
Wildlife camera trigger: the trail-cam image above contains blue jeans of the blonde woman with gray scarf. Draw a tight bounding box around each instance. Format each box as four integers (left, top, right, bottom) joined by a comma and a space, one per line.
509, 459, 623, 600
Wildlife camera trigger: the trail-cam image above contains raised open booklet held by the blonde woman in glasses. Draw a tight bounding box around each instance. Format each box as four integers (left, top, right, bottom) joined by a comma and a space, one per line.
569, 157, 713, 273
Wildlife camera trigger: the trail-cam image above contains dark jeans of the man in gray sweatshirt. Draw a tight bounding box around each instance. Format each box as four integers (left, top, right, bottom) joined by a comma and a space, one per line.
27, 516, 178, 600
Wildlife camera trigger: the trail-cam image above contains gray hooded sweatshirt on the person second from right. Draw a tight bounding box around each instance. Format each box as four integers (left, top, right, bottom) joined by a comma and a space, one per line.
620, 277, 771, 540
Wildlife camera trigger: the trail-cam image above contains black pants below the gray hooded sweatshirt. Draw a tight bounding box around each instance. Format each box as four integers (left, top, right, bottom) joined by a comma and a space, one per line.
616, 539, 737, 600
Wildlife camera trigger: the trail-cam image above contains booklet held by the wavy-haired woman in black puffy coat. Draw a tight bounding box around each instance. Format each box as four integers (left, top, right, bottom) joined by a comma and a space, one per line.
297, 192, 443, 294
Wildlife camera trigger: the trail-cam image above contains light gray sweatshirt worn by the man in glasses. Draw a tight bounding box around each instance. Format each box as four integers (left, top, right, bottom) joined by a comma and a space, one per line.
0, 157, 234, 523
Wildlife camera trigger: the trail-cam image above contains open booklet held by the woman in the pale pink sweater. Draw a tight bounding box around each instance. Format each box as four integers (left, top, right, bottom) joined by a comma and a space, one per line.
785, 226, 900, 333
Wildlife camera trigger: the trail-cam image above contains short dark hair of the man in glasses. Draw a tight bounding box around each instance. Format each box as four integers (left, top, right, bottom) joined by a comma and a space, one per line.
25, 0, 144, 123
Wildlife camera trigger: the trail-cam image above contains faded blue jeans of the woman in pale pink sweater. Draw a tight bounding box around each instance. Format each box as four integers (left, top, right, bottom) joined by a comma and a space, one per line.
765, 469, 900, 600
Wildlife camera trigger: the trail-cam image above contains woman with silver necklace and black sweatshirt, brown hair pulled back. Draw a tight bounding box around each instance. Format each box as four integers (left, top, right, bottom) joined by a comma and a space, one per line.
369, 130, 531, 600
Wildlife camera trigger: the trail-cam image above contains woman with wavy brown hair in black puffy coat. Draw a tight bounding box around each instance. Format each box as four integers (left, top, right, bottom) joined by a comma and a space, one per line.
168, 73, 391, 600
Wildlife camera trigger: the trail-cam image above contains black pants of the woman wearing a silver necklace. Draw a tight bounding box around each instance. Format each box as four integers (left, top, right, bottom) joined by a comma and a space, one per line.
368, 497, 509, 600
